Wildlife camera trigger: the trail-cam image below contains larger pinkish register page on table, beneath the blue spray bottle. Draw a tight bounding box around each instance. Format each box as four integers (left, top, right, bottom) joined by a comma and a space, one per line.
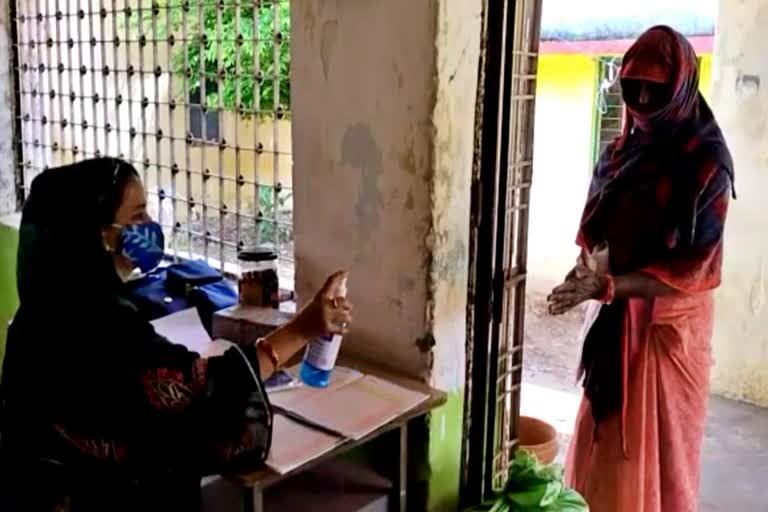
272, 375, 428, 440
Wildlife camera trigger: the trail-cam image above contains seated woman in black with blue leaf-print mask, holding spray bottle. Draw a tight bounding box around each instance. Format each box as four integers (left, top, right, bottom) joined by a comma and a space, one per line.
0, 158, 351, 511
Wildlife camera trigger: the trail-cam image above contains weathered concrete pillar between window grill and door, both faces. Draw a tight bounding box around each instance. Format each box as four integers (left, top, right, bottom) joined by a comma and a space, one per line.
291, 0, 481, 510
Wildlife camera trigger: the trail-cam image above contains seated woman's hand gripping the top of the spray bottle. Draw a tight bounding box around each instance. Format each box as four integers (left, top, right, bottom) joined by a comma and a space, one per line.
293, 272, 352, 339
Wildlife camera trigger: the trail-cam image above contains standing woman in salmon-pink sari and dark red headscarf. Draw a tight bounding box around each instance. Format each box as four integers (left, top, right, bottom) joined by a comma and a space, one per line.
549, 26, 734, 512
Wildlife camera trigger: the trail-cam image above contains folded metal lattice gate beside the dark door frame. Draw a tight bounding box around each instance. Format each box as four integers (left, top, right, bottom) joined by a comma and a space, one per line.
491, 0, 541, 490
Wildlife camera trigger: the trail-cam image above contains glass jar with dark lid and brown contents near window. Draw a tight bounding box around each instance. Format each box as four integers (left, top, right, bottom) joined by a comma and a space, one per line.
237, 248, 280, 308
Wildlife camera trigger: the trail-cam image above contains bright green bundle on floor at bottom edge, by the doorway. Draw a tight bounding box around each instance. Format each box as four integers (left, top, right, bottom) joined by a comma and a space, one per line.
467, 450, 589, 512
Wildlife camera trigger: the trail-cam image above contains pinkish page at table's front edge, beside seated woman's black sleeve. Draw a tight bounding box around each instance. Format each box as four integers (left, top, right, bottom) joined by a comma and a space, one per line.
267, 413, 343, 475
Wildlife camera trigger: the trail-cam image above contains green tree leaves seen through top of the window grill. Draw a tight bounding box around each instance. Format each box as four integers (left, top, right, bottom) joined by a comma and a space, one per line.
128, 0, 291, 115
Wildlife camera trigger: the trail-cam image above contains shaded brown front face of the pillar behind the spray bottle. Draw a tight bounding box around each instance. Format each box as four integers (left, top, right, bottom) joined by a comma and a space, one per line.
291, 0, 439, 381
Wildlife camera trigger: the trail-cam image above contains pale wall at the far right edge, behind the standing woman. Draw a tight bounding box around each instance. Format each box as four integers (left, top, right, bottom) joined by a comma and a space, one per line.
712, 0, 768, 405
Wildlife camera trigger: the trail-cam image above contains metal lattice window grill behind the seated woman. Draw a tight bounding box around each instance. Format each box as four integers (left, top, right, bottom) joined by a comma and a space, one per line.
14, 0, 293, 280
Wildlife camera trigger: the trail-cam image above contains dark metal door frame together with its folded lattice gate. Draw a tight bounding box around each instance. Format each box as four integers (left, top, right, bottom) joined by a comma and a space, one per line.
461, 0, 542, 505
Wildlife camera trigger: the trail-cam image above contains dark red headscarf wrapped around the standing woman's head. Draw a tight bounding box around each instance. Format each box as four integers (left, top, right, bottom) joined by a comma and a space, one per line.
619, 25, 699, 146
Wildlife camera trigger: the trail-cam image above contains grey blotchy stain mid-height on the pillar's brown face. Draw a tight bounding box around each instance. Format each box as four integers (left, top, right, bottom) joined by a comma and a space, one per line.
341, 123, 384, 235
